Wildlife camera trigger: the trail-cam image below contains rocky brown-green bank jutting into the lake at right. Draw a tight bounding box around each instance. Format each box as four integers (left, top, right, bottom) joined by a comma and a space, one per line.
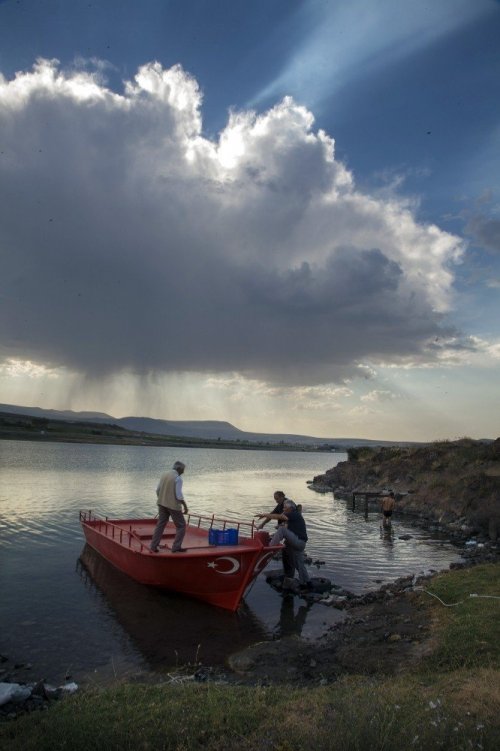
310, 438, 500, 540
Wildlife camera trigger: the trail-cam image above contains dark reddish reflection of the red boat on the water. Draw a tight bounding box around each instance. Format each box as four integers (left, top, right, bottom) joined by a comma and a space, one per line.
77, 545, 269, 672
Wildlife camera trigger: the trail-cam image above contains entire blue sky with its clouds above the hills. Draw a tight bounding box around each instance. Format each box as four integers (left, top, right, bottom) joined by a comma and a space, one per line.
0, 0, 500, 441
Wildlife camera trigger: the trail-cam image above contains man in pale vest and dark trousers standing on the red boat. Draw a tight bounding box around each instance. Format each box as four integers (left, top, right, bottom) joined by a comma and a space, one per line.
150, 462, 188, 553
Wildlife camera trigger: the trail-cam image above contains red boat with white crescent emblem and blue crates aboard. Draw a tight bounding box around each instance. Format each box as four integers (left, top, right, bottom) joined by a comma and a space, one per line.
80, 511, 281, 611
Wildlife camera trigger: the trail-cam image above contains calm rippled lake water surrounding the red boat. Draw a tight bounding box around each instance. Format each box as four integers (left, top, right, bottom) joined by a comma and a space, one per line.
0, 441, 459, 684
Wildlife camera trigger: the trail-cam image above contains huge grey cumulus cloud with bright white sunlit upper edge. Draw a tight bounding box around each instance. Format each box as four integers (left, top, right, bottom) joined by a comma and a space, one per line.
0, 60, 468, 385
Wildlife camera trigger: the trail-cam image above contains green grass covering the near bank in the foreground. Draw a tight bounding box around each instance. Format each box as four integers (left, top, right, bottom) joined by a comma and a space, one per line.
0, 565, 500, 751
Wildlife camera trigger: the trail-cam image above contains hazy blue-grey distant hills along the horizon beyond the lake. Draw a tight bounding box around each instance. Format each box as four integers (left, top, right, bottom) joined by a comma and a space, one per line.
0, 404, 418, 450
